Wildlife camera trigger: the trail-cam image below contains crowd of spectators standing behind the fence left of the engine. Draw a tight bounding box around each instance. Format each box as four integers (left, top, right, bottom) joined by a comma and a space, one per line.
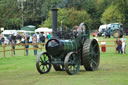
0, 32, 51, 55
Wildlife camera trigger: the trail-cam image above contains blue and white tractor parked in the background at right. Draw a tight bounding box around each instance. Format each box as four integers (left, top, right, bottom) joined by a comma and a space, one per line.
98, 23, 124, 38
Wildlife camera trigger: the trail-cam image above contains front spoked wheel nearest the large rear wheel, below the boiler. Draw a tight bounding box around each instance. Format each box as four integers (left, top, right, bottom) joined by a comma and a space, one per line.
64, 52, 80, 75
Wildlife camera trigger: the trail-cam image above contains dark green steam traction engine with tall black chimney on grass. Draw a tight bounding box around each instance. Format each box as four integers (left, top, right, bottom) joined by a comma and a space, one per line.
36, 8, 100, 75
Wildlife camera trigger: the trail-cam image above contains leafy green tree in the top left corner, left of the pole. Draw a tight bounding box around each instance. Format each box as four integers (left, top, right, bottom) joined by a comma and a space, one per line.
0, 0, 21, 29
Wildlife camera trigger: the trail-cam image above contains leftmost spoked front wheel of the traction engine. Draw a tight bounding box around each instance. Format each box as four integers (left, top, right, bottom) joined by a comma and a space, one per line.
36, 52, 51, 74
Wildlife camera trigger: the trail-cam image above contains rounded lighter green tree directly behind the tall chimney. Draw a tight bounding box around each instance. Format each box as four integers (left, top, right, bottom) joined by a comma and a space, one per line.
41, 8, 91, 28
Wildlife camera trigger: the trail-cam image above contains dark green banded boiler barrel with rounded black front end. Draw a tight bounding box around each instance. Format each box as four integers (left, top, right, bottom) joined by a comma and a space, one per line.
46, 39, 80, 56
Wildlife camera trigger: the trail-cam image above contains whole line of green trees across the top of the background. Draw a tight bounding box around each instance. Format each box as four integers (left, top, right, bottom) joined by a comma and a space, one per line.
0, 0, 128, 29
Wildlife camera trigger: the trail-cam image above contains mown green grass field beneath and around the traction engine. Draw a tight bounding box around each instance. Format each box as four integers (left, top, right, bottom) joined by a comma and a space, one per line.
0, 37, 128, 85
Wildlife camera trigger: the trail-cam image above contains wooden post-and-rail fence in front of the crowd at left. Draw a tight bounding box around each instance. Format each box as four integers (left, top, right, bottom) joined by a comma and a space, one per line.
0, 43, 45, 57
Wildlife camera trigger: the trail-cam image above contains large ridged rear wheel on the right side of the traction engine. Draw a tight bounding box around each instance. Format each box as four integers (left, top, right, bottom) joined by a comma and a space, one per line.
82, 39, 100, 71
